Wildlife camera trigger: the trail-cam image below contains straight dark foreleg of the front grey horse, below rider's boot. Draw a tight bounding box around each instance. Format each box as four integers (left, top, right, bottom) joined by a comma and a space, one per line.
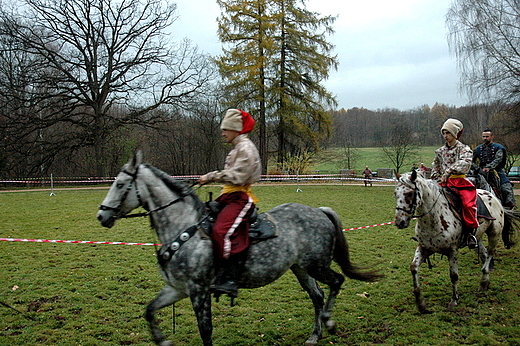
189, 284, 213, 346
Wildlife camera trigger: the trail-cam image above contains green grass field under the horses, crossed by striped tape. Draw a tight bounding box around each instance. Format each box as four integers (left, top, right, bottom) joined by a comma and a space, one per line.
0, 185, 520, 346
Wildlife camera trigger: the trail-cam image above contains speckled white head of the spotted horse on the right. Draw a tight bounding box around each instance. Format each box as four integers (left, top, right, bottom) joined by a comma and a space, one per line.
394, 170, 421, 229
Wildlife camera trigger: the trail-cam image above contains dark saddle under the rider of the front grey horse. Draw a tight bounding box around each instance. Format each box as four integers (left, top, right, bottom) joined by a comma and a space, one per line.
204, 201, 278, 242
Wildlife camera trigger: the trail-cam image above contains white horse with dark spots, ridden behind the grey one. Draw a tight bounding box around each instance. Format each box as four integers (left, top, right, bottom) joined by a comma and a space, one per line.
394, 171, 520, 313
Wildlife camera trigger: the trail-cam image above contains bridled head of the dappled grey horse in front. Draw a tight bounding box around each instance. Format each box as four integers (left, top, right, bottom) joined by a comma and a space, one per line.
97, 150, 143, 228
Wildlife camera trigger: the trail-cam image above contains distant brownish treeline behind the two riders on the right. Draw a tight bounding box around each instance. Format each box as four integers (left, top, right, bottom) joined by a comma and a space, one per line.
329, 103, 520, 154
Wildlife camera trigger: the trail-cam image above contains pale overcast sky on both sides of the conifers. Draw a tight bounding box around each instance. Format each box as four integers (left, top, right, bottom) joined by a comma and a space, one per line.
168, 0, 468, 110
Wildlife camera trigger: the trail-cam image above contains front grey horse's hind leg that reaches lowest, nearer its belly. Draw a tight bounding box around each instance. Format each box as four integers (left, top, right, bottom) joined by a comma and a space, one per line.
291, 264, 325, 346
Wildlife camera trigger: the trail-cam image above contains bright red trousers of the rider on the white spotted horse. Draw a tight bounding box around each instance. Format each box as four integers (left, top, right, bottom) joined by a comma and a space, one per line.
444, 178, 479, 228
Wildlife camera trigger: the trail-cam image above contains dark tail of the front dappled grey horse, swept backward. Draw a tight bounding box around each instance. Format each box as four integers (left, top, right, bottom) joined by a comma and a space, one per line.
319, 207, 384, 282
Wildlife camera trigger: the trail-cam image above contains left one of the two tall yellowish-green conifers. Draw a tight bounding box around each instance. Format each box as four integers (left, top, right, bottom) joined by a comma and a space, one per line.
216, 0, 273, 172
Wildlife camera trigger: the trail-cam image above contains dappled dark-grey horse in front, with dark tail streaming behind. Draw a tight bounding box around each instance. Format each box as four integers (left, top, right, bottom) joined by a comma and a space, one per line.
98, 152, 381, 346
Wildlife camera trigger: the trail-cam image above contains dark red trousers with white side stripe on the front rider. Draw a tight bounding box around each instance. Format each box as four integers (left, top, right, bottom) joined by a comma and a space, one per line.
212, 191, 255, 259
